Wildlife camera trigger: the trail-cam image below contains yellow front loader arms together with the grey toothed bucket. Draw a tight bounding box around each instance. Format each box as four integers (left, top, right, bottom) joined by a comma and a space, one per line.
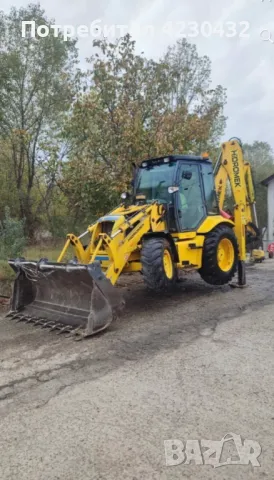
8, 202, 166, 338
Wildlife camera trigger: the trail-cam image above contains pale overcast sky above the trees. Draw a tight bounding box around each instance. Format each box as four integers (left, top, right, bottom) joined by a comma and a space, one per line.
0, 0, 274, 149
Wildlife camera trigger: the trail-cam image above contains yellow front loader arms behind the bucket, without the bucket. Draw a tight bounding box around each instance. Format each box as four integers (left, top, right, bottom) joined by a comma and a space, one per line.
58, 202, 166, 285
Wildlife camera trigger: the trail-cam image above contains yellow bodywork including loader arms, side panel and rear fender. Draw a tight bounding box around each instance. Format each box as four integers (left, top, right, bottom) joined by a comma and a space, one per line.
58, 212, 234, 285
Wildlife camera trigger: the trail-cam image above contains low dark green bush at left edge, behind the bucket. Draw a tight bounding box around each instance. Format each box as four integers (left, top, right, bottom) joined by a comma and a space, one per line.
0, 207, 26, 259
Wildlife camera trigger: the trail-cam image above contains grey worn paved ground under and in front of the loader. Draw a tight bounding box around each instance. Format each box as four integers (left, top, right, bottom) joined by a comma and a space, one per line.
0, 260, 274, 480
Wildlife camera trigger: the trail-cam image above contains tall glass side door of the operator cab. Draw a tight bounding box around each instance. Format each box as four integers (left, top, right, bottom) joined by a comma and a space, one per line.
176, 162, 206, 232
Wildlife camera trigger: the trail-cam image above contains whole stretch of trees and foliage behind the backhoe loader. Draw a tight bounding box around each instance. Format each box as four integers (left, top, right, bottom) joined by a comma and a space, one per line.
0, 3, 273, 240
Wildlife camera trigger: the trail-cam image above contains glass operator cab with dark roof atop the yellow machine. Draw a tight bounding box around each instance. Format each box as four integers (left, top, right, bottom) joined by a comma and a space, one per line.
134, 155, 219, 231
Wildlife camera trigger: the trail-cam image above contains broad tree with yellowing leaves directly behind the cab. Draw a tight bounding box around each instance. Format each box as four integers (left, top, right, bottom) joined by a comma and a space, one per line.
61, 35, 225, 218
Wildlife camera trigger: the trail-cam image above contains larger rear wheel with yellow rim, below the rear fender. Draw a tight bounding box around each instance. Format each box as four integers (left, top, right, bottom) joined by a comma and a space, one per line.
199, 225, 239, 285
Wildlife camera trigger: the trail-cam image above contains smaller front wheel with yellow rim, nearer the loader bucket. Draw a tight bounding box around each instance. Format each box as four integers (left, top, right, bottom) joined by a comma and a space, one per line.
141, 237, 177, 292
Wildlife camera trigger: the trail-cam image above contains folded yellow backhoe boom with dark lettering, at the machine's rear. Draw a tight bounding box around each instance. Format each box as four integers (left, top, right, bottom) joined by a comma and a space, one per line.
214, 139, 258, 261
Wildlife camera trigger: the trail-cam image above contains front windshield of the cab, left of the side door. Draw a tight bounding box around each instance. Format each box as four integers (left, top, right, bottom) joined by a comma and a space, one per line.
136, 162, 176, 203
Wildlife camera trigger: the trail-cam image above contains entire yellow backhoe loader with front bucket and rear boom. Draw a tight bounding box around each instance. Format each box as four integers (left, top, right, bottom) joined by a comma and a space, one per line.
8, 139, 259, 338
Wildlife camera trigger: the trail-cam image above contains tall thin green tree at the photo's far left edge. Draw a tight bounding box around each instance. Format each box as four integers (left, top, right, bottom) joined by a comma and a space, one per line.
0, 4, 77, 237
